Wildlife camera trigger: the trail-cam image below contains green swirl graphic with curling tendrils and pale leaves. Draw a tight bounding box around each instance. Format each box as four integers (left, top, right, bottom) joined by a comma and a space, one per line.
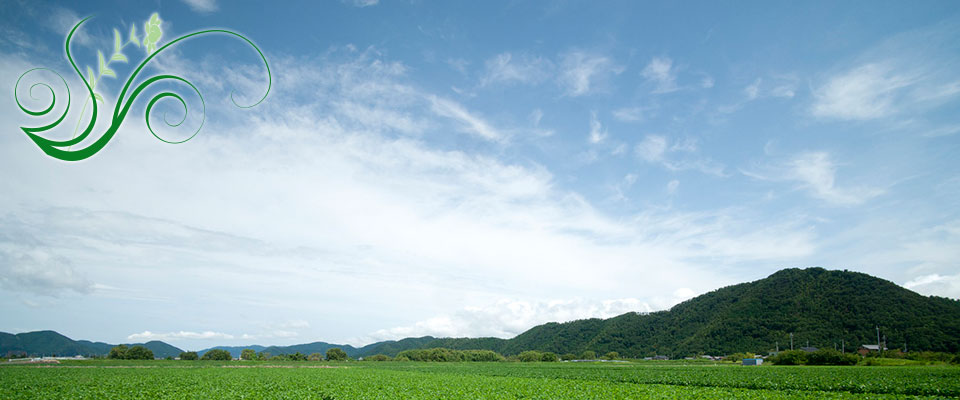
14, 14, 273, 161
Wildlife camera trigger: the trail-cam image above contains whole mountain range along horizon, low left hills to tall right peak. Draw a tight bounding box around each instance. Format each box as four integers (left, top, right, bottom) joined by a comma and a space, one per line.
7, 268, 960, 358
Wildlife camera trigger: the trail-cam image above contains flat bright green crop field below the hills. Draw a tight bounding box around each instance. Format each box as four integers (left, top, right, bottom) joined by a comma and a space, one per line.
0, 361, 960, 400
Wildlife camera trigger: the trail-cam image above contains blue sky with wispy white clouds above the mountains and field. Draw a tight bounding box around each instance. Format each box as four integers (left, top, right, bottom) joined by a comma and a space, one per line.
0, 1, 960, 349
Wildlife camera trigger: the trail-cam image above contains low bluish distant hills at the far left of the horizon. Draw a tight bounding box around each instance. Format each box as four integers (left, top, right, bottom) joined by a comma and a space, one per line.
0, 331, 183, 358
